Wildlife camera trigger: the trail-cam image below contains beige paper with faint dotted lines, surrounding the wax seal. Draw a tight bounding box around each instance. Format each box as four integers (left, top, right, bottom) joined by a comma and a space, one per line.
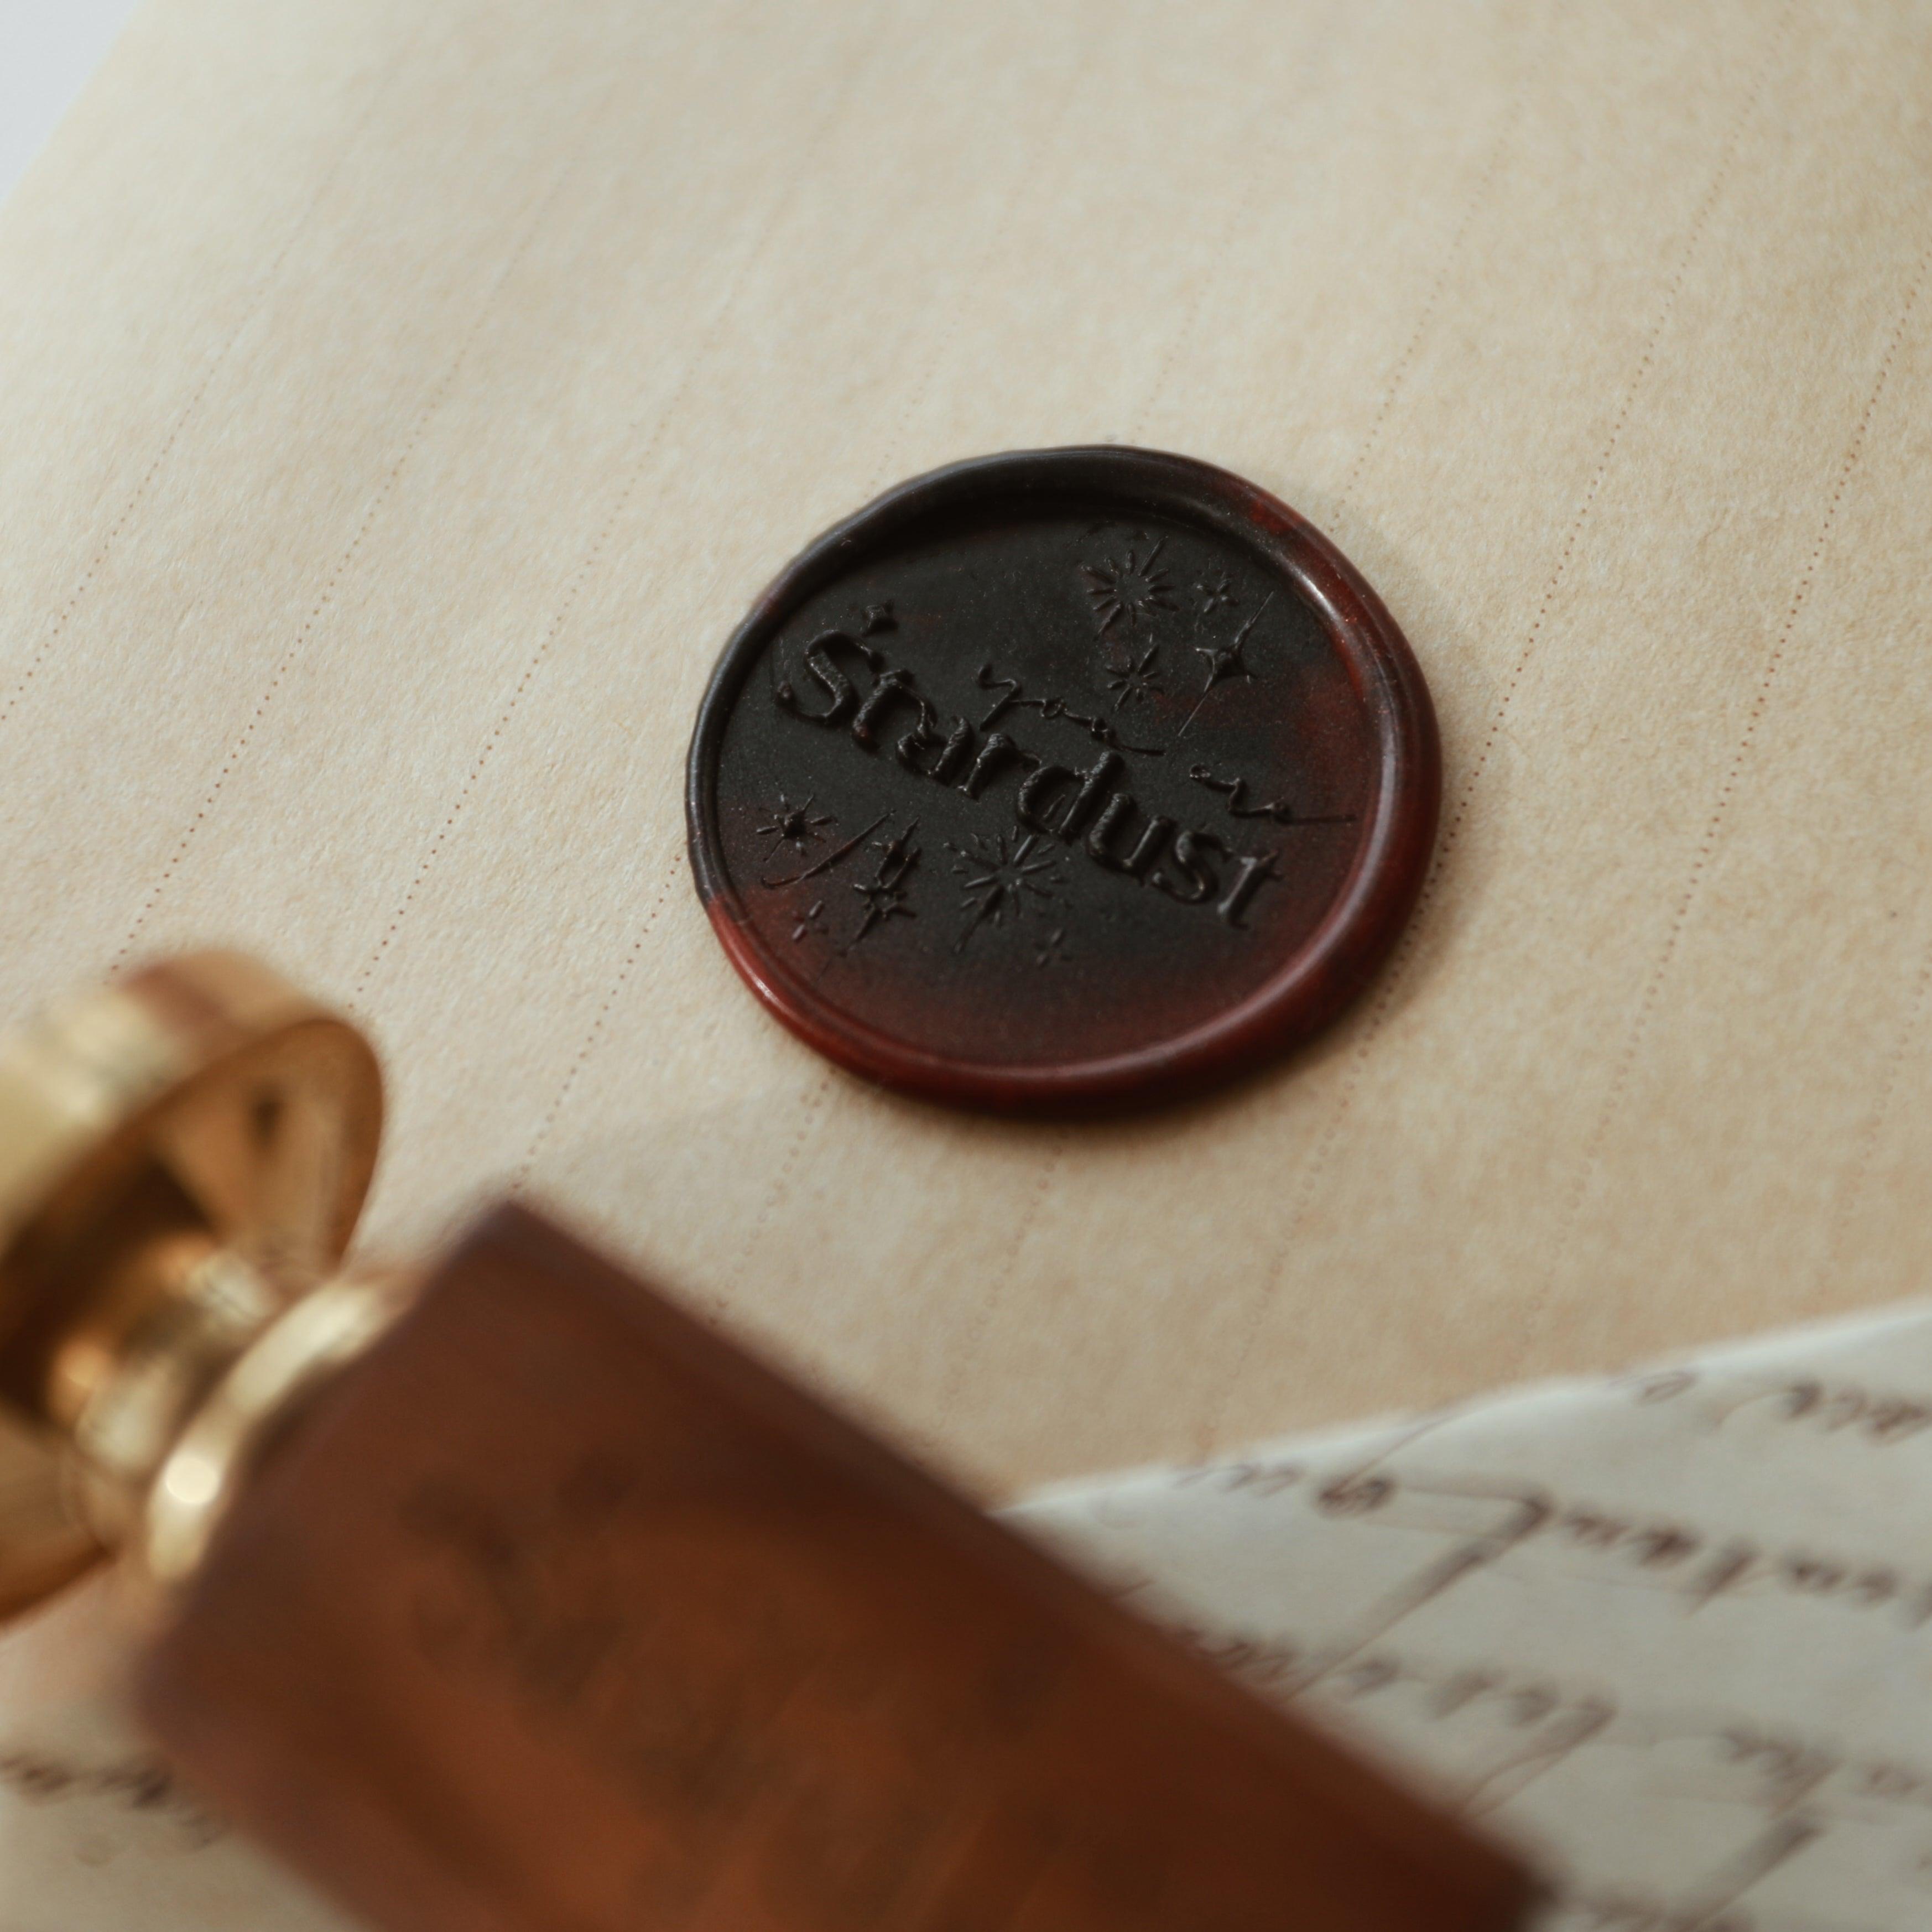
0, 0, 1932, 1488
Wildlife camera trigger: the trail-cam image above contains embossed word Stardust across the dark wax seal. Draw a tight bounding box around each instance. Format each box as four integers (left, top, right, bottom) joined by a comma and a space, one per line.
773, 630, 1277, 928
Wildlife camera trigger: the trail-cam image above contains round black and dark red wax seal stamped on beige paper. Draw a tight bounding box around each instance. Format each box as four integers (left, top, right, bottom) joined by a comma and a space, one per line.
688, 448, 1441, 1113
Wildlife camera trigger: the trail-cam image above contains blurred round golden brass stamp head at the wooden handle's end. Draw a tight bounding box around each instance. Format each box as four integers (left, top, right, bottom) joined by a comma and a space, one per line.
0, 952, 383, 1613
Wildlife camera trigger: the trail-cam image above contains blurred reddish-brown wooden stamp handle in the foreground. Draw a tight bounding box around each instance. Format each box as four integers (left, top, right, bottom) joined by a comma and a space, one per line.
143, 1207, 1530, 1932
